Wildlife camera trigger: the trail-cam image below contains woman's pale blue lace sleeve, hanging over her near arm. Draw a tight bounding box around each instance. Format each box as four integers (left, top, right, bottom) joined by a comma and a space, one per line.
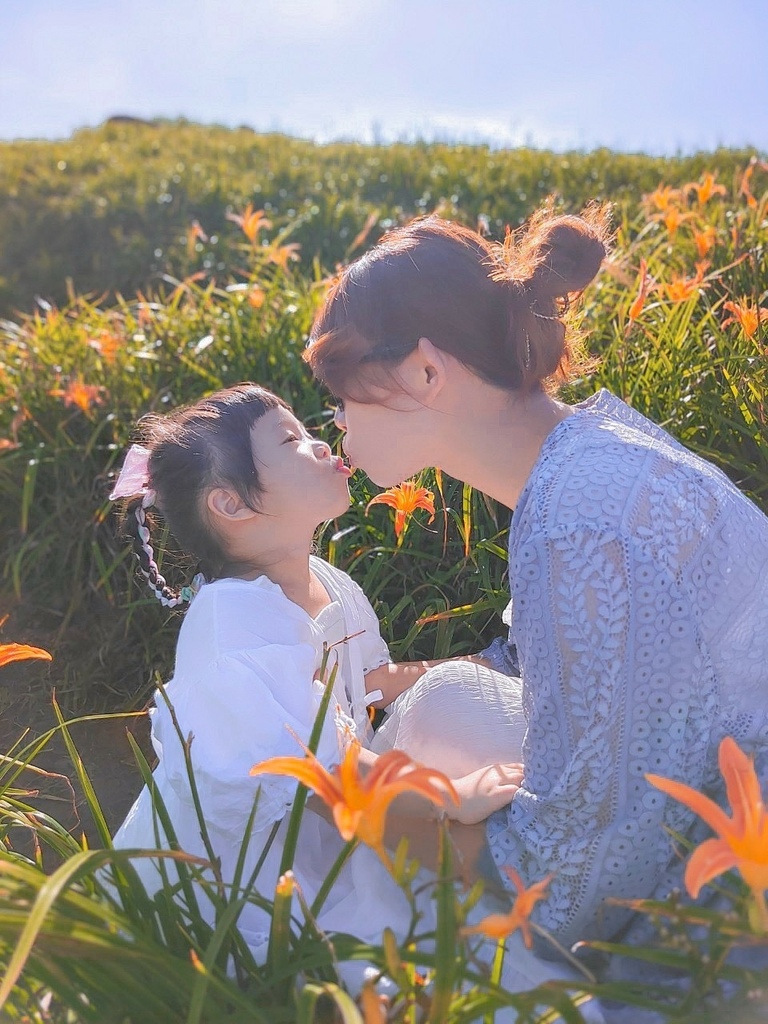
488, 526, 717, 944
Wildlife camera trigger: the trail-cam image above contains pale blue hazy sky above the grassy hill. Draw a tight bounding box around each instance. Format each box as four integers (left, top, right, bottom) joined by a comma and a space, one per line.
0, 0, 768, 155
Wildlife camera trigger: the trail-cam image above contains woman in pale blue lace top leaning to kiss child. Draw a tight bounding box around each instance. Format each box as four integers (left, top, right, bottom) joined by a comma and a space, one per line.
305, 209, 768, 958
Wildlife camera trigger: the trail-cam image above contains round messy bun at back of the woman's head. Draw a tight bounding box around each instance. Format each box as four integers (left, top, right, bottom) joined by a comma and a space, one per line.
520, 209, 607, 299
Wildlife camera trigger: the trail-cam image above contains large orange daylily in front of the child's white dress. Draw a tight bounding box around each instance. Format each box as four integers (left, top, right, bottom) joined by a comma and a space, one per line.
251, 740, 459, 863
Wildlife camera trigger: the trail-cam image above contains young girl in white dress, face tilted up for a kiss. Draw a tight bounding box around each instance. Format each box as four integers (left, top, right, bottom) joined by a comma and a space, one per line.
113, 384, 524, 978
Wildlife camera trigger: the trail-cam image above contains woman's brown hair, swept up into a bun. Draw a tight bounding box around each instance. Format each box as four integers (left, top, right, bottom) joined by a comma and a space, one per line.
304, 205, 608, 401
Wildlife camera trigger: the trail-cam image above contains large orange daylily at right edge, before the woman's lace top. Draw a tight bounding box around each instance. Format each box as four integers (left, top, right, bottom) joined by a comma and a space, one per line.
645, 736, 768, 929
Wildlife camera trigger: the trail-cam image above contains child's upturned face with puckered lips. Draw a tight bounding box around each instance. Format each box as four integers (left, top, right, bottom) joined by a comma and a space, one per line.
251, 408, 350, 528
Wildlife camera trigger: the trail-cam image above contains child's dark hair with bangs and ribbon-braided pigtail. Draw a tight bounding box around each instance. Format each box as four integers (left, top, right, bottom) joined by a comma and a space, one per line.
124, 383, 290, 607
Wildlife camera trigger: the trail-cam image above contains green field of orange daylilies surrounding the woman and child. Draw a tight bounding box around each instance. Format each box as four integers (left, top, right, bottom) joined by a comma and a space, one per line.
0, 125, 768, 1024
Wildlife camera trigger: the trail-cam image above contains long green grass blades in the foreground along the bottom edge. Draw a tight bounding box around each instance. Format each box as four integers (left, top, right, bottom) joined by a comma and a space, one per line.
0, 692, 766, 1024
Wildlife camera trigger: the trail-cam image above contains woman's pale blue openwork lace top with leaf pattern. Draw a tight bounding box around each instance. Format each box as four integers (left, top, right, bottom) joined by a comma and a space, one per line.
483, 391, 768, 943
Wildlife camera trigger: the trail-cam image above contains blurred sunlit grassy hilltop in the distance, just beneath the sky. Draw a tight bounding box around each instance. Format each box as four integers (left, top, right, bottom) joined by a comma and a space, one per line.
0, 121, 751, 315
